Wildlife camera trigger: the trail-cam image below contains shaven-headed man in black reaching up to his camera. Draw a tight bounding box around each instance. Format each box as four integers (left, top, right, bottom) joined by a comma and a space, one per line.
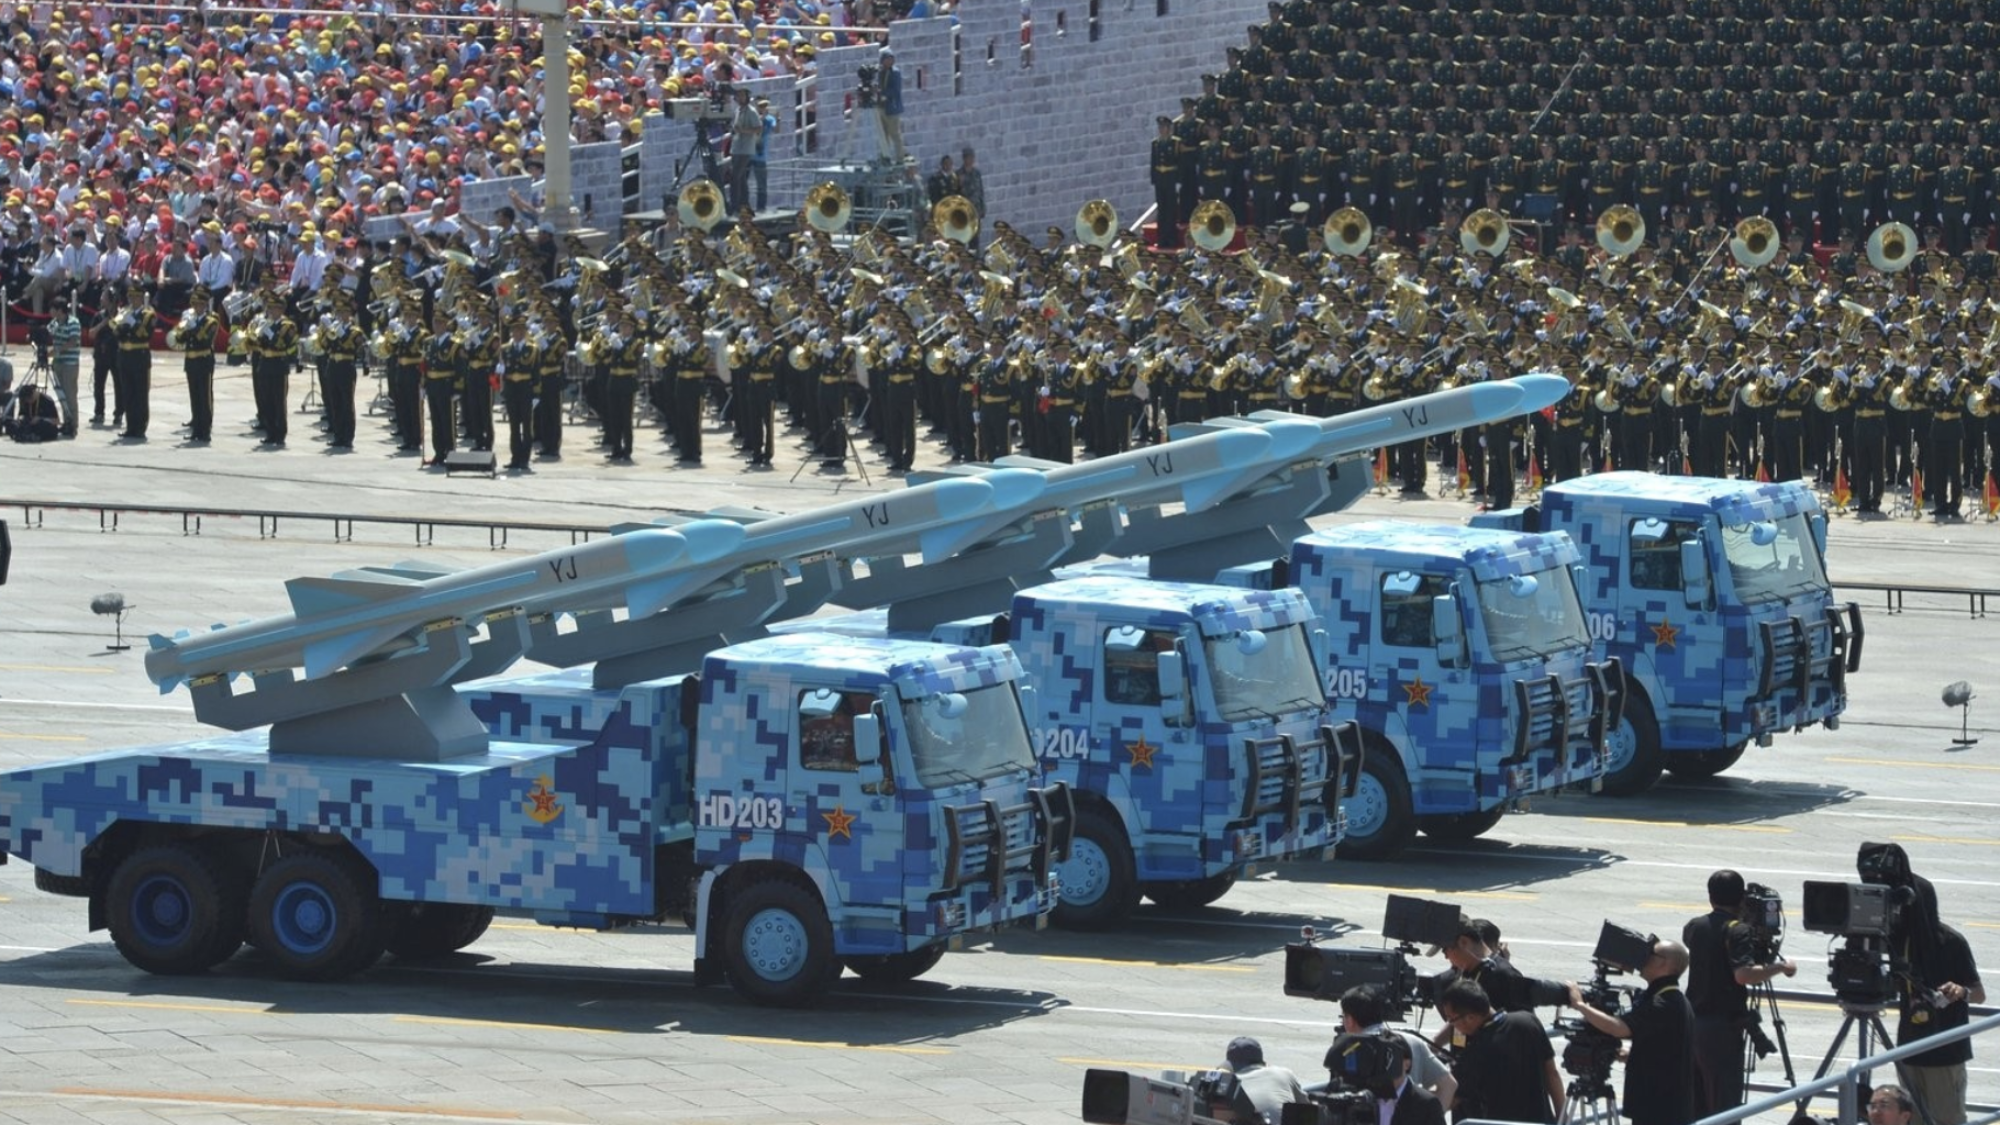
1570, 941, 1696, 1125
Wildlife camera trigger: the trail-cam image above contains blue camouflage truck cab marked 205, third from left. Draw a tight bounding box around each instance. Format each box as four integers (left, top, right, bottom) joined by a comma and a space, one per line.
1224, 520, 1618, 859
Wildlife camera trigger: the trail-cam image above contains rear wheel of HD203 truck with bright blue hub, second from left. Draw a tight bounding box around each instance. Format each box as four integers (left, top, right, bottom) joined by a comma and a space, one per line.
250, 851, 388, 981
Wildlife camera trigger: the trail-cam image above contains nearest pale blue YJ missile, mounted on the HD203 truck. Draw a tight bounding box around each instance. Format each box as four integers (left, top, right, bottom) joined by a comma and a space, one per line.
146, 520, 744, 695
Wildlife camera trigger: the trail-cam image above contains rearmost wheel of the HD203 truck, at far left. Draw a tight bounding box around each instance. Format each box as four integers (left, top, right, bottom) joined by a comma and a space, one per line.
104, 845, 244, 975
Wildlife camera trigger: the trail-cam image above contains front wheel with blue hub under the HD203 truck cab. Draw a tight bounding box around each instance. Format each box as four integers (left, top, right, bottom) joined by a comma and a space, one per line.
722, 879, 840, 1007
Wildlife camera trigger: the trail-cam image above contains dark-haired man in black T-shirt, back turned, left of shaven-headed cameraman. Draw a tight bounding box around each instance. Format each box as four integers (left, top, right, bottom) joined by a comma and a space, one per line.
1438, 981, 1564, 1125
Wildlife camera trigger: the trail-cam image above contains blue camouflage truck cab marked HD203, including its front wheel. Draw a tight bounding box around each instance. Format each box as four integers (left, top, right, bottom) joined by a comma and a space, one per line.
468, 635, 1072, 1003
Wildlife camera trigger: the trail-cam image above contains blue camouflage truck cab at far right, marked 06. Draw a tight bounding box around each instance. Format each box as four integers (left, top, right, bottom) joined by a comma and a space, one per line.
1474, 472, 1862, 795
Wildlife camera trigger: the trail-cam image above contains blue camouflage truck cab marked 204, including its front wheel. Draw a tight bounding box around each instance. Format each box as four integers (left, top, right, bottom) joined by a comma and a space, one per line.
934, 575, 1356, 927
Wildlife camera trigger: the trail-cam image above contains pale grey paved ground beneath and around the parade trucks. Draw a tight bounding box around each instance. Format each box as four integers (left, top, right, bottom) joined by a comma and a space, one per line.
0, 356, 2000, 1125
